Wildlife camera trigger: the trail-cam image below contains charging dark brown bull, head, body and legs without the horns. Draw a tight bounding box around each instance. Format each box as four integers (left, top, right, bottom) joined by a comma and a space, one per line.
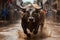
21, 5, 44, 37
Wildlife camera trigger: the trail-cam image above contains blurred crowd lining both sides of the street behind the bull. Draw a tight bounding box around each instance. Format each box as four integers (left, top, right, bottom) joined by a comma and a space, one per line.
0, 0, 60, 21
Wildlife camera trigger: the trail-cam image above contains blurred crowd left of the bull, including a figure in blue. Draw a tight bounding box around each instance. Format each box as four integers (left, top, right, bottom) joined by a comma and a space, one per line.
0, 0, 18, 21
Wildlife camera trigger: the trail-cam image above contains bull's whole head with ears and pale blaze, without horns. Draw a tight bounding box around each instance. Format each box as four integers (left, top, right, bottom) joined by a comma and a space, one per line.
19, 5, 39, 22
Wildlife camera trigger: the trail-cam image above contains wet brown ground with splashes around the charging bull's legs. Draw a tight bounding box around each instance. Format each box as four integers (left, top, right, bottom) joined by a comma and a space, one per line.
0, 20, 60, 40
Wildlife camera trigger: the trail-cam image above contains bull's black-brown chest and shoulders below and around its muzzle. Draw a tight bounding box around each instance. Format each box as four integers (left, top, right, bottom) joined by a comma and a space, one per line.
22, 10, 39, 31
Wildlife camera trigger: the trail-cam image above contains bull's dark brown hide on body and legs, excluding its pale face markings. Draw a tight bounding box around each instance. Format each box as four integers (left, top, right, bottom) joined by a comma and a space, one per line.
22, 9, 44, 37
